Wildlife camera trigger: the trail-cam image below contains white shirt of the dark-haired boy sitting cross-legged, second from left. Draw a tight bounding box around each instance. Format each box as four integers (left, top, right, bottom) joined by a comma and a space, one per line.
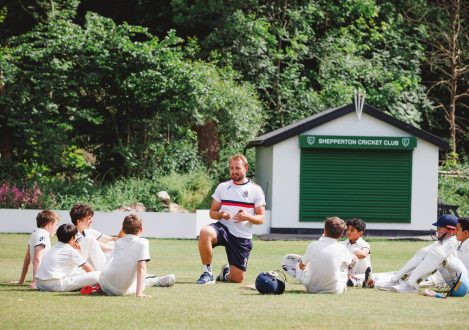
36, 242, 86, 281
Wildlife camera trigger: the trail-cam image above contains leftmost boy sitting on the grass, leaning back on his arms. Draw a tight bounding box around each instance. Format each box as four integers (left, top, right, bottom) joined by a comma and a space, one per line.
12, 210, 60, 289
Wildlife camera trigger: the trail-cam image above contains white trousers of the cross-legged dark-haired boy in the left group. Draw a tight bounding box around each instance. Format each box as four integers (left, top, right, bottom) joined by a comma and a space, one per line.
36, 271, 101, 292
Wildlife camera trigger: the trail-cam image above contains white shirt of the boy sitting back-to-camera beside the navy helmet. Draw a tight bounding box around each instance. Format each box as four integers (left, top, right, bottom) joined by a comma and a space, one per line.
301, 237, 353, 293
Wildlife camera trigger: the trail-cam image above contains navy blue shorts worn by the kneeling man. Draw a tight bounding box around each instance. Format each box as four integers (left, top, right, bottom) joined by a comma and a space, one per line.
210, 222, 252, 271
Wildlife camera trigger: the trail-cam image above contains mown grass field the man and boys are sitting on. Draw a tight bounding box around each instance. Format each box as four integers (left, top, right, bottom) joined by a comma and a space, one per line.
0, 234, 469, 329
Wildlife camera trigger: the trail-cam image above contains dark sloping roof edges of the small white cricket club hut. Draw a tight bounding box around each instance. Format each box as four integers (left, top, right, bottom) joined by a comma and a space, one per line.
247, 104, 449, 150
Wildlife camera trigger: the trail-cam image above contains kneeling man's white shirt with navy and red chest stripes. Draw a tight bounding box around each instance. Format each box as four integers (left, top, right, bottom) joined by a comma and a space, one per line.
212, 180, 265, 239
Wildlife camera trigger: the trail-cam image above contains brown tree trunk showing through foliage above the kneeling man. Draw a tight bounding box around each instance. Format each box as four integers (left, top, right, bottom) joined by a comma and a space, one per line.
194, 120, 220, 166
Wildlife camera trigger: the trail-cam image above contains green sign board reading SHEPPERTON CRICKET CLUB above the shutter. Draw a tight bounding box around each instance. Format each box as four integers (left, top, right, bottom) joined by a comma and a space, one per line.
300, 135, 417, 150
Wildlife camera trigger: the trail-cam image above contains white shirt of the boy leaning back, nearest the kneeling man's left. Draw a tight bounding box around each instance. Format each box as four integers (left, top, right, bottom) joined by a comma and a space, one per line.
99, 234, 150, 296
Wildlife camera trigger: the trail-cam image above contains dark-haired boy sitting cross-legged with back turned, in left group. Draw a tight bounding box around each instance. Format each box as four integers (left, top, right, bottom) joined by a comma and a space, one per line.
36, 223, 100, 292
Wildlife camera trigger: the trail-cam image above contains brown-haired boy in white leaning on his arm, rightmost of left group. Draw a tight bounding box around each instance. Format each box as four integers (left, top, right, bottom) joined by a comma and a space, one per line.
99, 214, 176, 297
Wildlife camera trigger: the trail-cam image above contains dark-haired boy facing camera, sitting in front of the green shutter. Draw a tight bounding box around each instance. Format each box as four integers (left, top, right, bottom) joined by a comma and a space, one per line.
341, 218, 374, 288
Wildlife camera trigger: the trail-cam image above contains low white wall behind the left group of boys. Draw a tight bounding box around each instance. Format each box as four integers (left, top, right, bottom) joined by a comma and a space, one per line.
0, 209, 270, 239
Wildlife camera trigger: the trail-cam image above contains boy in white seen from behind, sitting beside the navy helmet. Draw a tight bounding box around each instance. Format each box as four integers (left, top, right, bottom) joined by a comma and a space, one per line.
282, 217, 358, 294
